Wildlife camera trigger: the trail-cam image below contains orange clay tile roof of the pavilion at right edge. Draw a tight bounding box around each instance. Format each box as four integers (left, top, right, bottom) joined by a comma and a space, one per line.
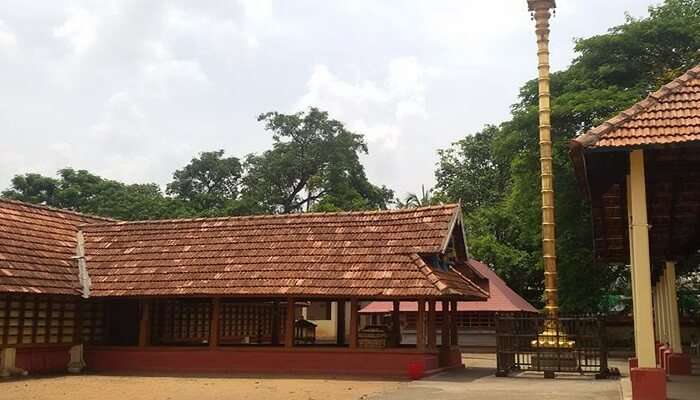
573, 65, 700, 148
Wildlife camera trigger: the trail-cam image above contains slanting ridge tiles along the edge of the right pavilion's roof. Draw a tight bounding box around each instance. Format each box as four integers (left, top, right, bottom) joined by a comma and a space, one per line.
572, 65, 700, 147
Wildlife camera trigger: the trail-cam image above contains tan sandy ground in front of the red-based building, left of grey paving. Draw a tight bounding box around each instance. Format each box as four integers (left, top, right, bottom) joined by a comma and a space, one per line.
0, 375, 400, 400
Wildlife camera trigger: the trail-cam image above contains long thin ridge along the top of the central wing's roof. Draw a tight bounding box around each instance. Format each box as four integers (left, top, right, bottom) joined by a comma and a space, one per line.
82, 203, 459, 226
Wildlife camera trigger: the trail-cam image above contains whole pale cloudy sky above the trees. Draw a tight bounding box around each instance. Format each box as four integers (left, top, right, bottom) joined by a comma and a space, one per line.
0, 0, 659, 196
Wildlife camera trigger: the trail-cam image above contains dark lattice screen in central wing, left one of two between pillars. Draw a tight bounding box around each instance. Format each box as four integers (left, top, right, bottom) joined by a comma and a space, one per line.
151, 299, 211, 344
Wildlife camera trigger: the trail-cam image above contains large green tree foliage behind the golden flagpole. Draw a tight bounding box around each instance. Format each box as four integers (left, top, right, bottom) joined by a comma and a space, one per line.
436, 0, 700, 312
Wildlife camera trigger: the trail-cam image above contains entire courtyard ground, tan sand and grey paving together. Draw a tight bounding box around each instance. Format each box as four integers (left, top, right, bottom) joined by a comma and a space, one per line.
0, 354, 636, 400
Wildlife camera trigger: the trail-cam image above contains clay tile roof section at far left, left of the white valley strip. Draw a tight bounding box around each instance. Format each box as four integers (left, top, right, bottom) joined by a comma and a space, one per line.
0, 199, 111, 294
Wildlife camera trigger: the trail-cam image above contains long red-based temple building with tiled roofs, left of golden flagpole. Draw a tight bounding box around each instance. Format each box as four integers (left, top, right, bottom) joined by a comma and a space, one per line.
0, 200, 488, 375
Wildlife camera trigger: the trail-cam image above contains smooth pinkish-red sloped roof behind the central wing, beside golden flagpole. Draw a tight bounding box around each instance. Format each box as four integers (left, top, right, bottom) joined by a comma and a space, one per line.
360, 259, 537, 313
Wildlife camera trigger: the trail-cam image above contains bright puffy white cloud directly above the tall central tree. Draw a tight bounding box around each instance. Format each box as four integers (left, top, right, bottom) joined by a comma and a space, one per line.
296, 57, 439, 148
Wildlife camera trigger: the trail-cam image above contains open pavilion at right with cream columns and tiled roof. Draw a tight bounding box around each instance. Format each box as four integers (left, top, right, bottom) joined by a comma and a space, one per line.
571, 66, 700, 399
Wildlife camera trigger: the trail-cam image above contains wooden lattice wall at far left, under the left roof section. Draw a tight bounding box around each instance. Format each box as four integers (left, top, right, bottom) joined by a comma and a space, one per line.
0, 293, 77, 346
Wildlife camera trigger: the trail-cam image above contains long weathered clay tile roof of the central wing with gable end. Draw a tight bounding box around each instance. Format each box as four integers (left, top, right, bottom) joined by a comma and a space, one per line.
83, 205, 486, 299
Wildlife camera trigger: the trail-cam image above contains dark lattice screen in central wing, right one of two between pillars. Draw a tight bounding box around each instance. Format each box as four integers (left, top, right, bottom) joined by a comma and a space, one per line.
219, 301, 287, 344
